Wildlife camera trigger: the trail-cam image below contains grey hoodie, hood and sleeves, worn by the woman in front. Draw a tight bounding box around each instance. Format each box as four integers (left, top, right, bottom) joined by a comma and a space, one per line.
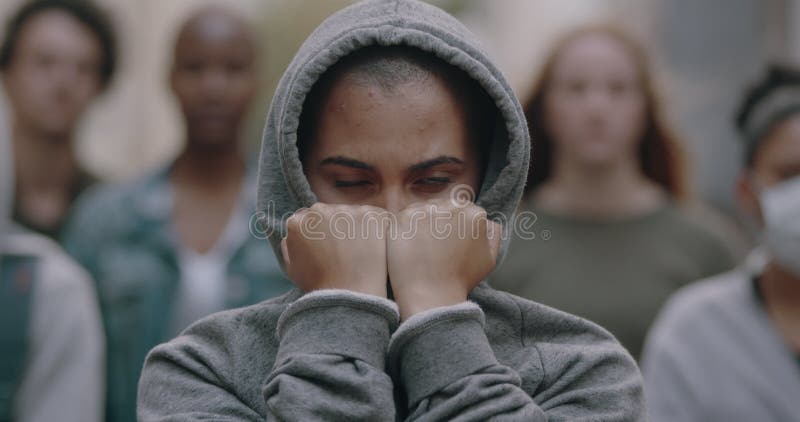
138, 0, 644, 421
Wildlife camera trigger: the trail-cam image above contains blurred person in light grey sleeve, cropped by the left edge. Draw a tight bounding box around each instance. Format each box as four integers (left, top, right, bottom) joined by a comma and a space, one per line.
0, 100, 104, 422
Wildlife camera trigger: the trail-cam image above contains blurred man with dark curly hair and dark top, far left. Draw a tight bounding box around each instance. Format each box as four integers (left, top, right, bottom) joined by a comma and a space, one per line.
0, 0, 115, 238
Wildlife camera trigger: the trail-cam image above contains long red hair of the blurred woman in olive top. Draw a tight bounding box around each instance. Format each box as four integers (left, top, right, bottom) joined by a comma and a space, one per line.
525, 25, 689, 200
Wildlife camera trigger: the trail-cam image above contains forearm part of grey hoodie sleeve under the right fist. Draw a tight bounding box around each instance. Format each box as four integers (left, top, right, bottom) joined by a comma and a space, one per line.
389, 302, 547, 421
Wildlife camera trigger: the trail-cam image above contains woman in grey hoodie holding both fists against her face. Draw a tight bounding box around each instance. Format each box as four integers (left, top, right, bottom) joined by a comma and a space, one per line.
138, 0, 644, 421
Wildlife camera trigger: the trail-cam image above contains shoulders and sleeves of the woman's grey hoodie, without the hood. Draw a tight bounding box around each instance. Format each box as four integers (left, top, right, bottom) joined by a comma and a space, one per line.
138, 284, 645, 421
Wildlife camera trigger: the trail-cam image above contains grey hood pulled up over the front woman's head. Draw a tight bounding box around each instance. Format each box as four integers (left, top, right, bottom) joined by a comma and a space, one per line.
256, 0, 530, 266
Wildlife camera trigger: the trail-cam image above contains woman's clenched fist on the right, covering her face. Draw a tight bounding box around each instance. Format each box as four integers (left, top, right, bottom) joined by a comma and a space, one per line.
386, 200, 502, 320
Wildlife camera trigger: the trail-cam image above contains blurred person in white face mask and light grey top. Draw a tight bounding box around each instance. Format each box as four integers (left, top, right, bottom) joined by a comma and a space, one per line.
643, 66, 800, 422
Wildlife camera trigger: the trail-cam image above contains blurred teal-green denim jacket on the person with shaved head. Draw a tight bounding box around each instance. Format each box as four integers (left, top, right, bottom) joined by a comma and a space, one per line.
63, 168, 291, 422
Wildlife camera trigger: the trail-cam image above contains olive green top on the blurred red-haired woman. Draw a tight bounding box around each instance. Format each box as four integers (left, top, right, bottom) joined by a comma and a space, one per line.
490, 202, 736, 358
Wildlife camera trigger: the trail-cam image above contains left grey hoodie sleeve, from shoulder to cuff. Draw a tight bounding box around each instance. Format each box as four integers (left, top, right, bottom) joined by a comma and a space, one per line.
137, 290, 398, 422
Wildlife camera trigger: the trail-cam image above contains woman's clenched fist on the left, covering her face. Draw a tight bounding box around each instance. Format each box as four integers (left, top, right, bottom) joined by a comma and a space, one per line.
281, 203, 388, 297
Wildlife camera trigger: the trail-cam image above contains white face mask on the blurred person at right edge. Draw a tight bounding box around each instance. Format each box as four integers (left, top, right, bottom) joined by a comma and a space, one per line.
761, 176, 800, 277
